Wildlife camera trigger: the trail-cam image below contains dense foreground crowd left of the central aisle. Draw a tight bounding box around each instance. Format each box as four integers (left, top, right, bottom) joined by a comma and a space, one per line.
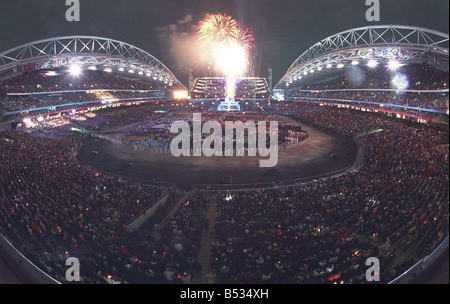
0, 131, 214, 283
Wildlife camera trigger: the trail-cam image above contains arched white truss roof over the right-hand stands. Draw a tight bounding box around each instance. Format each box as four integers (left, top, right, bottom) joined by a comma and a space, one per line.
275, 25, 449, 89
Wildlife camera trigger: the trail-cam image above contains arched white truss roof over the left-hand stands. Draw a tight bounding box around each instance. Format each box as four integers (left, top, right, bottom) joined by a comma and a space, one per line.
0, 36, 185, 88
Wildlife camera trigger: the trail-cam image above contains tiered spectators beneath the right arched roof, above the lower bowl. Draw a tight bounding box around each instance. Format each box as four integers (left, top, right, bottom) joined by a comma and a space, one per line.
287, 64, 449, 118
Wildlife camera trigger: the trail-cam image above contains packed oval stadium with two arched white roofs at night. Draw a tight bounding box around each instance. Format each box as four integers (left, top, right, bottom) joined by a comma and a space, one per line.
0, 5, 449, 284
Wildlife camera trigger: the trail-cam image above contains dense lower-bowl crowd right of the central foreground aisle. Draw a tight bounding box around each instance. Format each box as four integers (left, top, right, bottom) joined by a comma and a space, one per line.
209, 104, 448, 284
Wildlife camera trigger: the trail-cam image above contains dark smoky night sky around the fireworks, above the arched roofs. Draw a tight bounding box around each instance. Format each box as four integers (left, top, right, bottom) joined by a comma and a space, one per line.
0, 0, 449, 86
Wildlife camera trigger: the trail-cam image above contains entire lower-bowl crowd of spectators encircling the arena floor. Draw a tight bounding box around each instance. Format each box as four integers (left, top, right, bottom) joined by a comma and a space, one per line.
0, 84, 449, 284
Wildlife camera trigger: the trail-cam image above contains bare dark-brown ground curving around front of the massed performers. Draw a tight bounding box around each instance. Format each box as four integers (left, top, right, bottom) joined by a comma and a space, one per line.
77, 119, 358, 188
